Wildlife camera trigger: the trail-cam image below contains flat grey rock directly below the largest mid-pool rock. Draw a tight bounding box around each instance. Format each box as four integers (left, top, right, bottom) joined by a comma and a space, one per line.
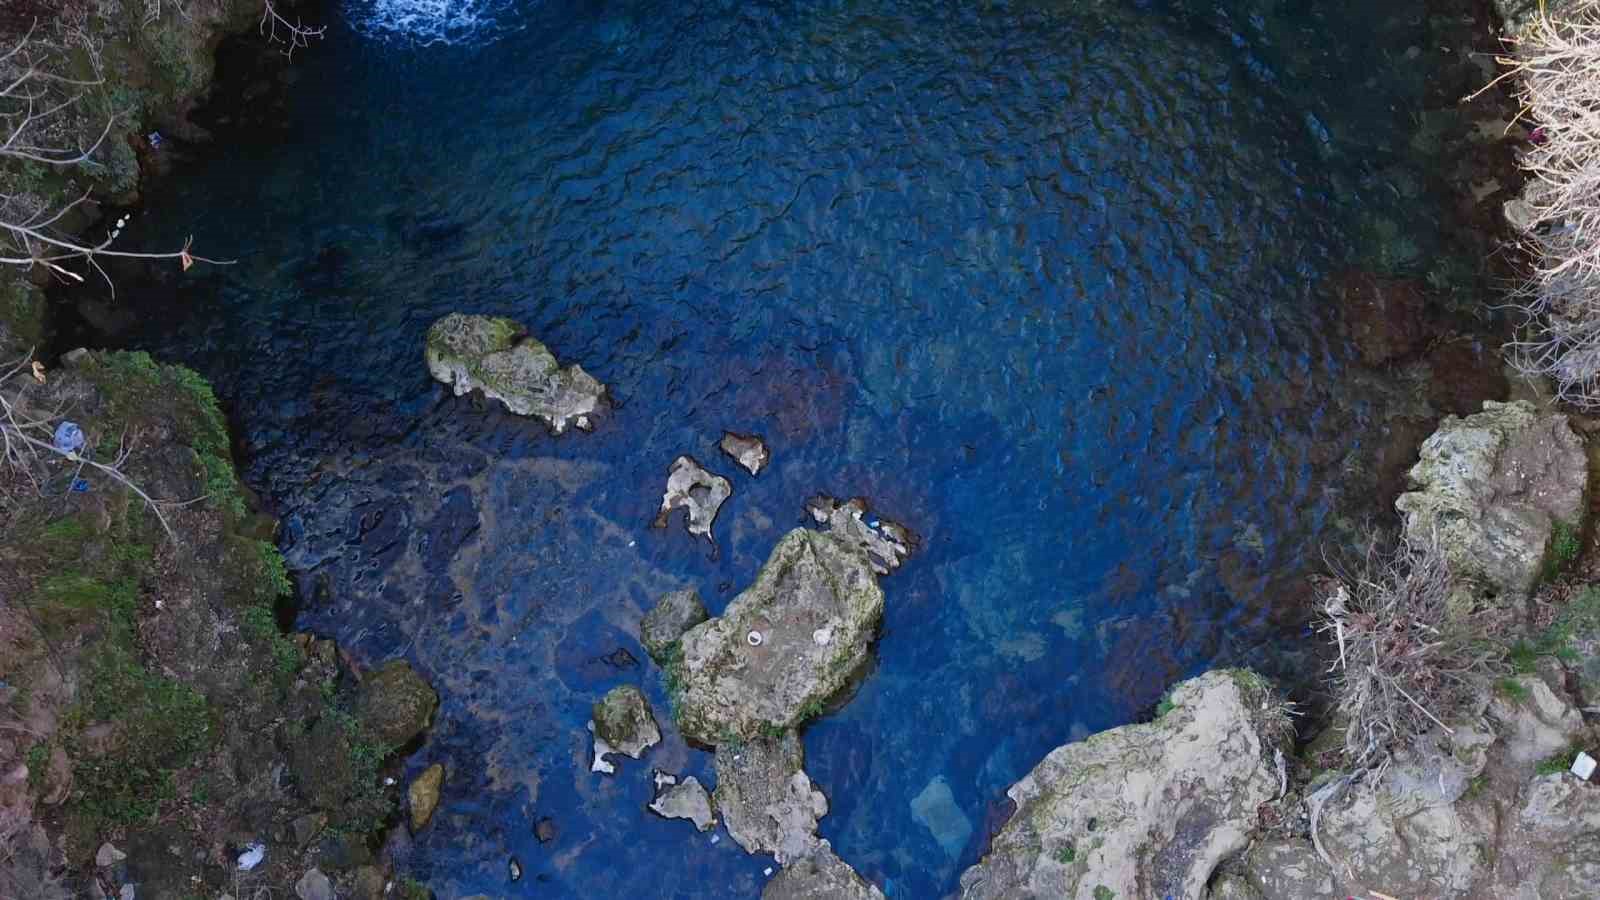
717, 732, 827, 865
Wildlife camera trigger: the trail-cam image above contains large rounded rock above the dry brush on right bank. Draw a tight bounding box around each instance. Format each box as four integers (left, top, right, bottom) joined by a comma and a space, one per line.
1395, 400, 1589, 597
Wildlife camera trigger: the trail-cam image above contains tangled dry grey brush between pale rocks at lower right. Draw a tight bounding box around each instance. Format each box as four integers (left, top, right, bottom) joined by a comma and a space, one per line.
1318, 528, 1506, 769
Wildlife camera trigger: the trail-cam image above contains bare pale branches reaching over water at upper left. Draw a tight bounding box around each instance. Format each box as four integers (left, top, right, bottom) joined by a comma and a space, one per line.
0, 14, 227, 293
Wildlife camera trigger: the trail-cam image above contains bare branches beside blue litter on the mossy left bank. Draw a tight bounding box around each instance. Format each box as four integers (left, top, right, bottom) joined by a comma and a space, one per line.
0, 352, 187, 541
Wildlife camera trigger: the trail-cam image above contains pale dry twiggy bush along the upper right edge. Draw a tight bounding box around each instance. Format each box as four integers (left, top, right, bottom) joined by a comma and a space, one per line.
1502, 0, 1600, 398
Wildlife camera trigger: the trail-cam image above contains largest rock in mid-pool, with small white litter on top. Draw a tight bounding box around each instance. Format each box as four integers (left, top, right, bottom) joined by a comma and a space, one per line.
672, 528, 883, 746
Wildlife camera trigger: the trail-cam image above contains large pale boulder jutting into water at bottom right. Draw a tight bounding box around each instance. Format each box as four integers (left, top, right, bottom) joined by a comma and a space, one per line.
962, 671, 1288, 900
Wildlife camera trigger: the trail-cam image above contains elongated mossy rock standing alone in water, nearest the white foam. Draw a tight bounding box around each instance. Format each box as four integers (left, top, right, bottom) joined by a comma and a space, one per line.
426, 312, 605, 434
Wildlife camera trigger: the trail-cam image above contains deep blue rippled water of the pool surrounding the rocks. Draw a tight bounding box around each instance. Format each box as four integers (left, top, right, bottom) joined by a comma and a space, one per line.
93, 0, 1472, 897
